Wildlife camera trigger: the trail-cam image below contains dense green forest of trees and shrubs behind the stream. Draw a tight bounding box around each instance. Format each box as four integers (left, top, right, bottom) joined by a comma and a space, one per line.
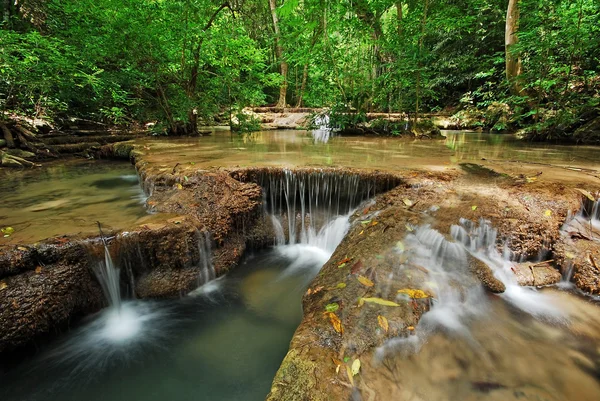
0, 0, 600, 139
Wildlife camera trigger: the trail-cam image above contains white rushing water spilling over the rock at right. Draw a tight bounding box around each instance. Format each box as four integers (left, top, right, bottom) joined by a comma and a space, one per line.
377, 219, 569, 358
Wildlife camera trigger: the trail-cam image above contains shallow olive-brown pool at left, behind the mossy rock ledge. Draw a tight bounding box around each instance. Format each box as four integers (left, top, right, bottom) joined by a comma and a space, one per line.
0, 161, 146, 244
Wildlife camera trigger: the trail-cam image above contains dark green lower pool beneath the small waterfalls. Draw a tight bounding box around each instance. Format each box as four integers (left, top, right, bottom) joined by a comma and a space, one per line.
0, 245, 329, 401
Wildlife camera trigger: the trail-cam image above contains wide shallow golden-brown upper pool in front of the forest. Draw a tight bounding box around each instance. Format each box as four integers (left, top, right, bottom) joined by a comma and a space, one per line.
137, 130, 600, 170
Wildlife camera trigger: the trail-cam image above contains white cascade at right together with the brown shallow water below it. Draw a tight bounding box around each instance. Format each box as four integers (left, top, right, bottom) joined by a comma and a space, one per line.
365, 219, 600, 401
